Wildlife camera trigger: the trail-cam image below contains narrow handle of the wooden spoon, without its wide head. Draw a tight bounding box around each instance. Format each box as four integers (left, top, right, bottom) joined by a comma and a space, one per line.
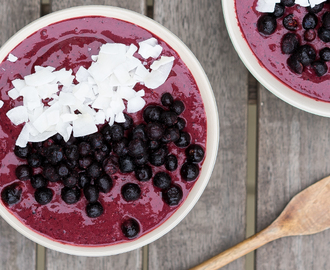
190, 225, 283, 270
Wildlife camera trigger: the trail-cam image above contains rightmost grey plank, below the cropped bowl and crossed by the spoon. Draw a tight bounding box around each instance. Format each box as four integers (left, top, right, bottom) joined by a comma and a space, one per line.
256, 87, 330, 270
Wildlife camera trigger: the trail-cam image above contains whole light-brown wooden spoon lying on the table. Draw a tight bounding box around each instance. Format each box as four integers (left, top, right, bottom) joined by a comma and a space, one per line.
190, 176, 330, 270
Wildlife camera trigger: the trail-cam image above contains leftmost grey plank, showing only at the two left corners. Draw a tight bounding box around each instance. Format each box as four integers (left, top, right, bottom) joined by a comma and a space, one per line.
0, 0, 40, 270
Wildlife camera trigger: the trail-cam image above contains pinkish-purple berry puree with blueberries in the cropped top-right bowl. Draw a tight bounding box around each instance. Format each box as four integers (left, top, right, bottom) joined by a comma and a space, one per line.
235, 0, 330, 102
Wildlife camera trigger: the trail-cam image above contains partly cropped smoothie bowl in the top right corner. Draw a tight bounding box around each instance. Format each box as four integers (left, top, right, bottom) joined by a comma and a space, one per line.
222, 0, 330, 117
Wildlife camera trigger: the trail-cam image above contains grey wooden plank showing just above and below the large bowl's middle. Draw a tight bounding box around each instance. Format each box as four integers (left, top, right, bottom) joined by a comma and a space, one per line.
46, 0, 146, 270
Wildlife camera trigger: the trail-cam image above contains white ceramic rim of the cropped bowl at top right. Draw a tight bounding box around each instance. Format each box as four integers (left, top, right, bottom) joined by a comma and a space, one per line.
222, 0, 330, 117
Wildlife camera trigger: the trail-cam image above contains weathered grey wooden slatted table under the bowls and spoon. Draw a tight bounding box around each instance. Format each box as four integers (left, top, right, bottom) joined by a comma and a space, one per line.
0, 0, 330, 270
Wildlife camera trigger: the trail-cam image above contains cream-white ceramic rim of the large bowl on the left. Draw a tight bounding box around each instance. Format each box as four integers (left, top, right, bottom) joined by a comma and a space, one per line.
0, 6, 219, 256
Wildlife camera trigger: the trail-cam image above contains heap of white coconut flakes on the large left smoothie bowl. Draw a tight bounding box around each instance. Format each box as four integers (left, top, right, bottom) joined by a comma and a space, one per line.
6, 38, 174, 147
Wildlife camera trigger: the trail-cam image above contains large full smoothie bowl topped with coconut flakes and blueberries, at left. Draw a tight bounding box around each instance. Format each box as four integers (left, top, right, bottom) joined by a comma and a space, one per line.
0, 6, 219, 256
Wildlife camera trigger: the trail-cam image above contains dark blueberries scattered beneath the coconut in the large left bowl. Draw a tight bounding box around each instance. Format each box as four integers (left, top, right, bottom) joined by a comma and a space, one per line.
1, 93, 204, 238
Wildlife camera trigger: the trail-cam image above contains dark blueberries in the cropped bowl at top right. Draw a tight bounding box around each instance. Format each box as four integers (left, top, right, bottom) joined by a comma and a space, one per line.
257, 0, 330, 77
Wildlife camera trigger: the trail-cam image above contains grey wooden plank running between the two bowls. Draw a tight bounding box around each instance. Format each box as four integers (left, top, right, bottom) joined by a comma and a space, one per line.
149, 0, 248, 270
